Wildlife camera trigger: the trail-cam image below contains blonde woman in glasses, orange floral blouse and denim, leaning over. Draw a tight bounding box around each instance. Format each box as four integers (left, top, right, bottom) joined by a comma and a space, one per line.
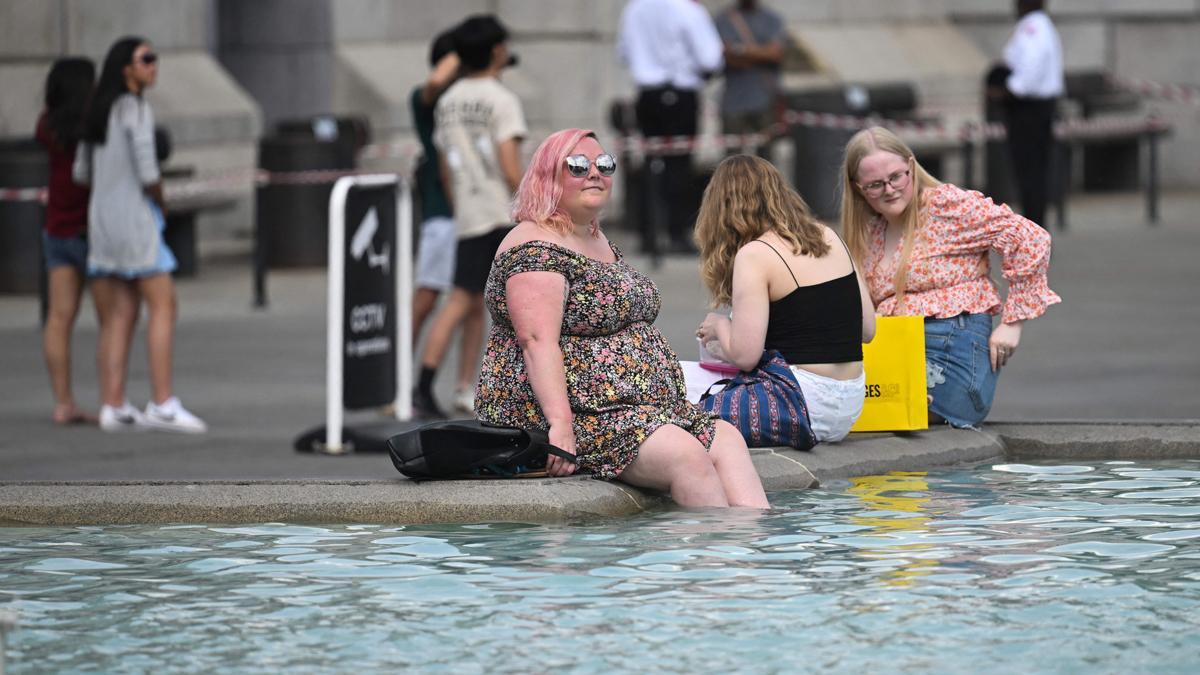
841, 126, 1062, 428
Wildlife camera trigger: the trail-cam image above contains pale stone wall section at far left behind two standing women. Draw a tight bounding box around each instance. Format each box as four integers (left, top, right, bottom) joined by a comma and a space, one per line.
0, 0, 262, 250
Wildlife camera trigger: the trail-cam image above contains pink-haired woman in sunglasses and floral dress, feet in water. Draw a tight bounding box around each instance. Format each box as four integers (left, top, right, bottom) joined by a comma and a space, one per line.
475, 129, 768, 508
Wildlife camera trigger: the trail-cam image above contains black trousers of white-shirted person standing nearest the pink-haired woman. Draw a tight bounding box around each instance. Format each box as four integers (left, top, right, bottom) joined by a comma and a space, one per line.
636, 86, 700, 250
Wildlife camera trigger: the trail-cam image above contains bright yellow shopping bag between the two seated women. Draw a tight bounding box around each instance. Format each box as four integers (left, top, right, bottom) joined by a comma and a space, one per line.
851, 316, 929, 431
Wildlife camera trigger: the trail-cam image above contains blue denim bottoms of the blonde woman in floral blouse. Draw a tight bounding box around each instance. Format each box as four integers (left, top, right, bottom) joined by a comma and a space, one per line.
925, 313, 997, 428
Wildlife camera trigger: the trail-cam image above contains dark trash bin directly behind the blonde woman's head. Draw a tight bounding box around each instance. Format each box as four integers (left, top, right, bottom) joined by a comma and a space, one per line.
786, 84, 929, 220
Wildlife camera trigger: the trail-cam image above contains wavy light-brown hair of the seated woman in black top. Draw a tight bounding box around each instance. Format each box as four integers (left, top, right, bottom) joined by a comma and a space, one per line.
695, 155, 829, 307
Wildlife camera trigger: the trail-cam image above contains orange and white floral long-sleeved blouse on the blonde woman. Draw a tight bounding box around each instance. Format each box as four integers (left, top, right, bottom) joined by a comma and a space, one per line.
863, 183, 1062, 323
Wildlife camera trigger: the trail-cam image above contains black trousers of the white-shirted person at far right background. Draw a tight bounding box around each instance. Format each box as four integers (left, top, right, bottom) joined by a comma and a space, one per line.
1006, 98, 1056, 227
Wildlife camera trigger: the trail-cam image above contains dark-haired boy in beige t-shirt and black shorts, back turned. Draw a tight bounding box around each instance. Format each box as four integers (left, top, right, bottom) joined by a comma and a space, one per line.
413, 14, 528, 417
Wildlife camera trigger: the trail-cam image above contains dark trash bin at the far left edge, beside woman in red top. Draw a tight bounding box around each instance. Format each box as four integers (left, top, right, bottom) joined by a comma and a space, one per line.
0, 138, 50, 293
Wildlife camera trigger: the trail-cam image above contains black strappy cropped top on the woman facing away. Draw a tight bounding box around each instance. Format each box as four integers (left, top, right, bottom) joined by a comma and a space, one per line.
755, 238, 863, 363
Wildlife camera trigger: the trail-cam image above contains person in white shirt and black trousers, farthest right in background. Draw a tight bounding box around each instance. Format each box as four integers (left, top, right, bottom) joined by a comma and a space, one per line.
1004, 0, 1063, 227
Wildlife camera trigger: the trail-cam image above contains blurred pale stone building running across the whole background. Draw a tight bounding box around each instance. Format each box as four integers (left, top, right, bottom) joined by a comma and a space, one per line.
0, 0, 1200, 250
